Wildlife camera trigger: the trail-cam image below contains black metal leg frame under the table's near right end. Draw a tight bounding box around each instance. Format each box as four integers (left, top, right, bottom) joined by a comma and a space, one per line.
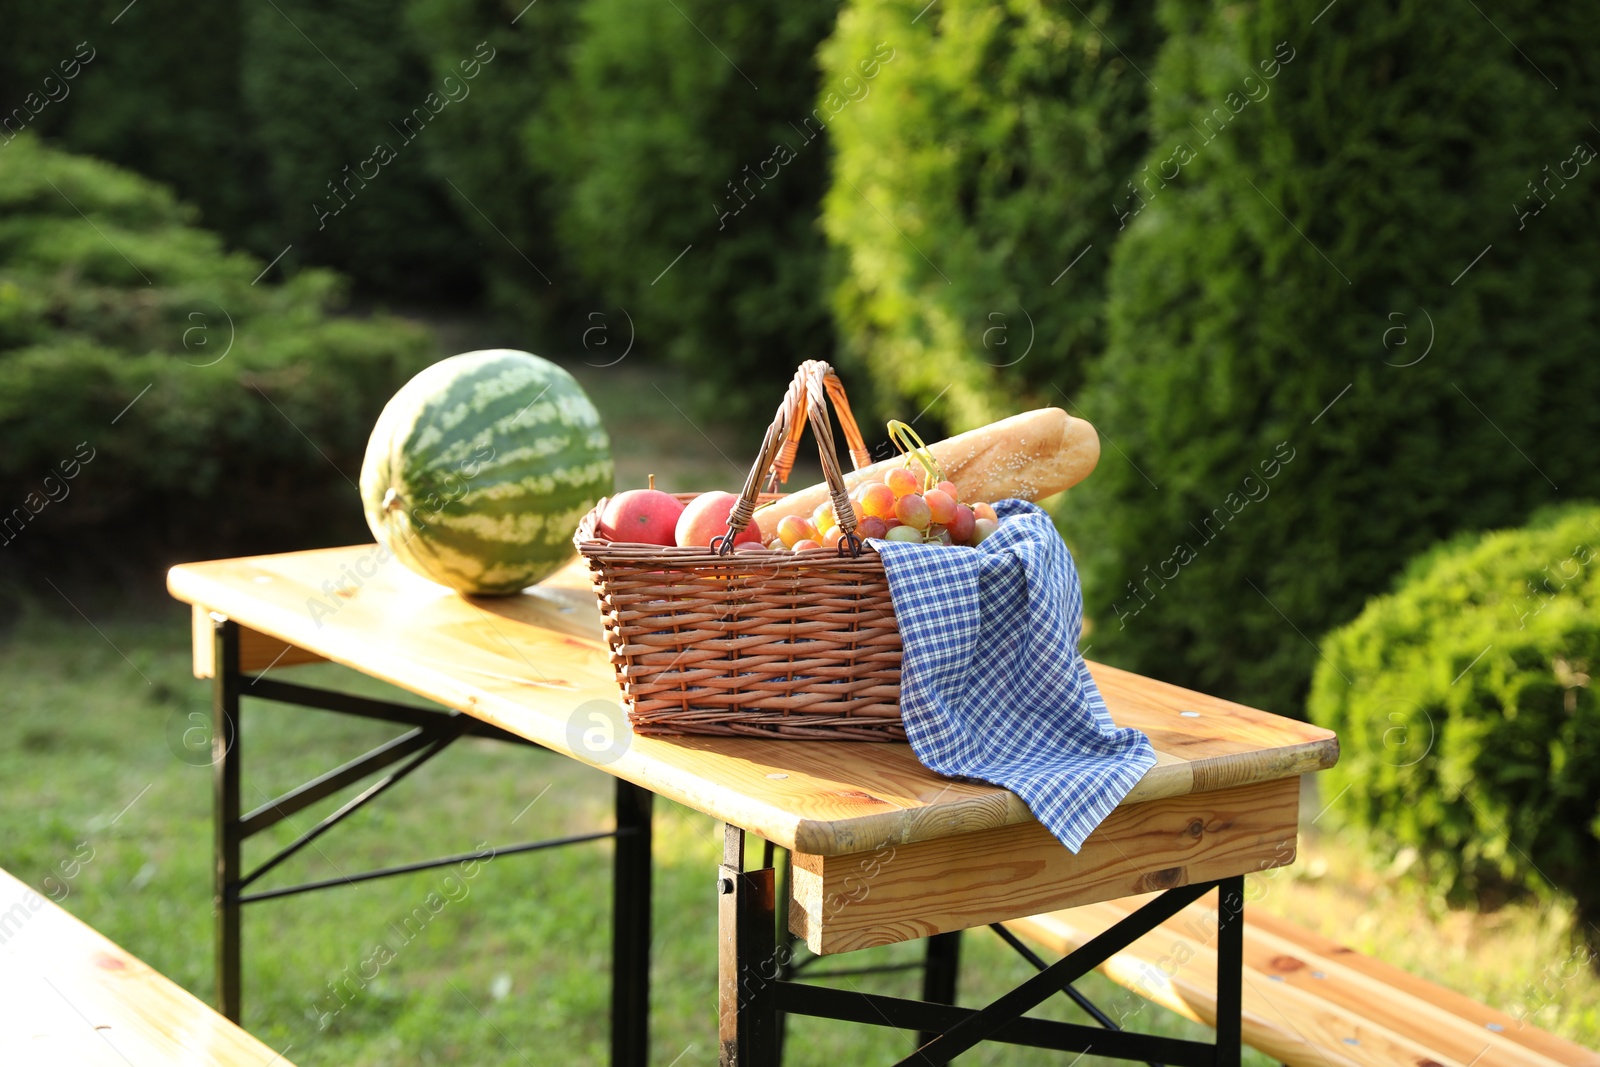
717, 825, 1245, 1067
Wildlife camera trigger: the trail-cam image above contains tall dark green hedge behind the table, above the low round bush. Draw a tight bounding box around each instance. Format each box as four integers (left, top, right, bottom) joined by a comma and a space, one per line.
1070, 0, 1600, 713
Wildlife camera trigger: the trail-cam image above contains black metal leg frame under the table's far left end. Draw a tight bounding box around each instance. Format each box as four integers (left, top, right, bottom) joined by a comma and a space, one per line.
211, 619, 653, 1067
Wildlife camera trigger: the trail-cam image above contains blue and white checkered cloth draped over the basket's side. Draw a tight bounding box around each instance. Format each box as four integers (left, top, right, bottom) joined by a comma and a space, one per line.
872, 501, 1155, 853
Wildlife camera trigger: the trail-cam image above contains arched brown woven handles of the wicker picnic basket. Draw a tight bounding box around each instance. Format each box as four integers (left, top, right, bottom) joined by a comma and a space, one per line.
726, 360, 872, 555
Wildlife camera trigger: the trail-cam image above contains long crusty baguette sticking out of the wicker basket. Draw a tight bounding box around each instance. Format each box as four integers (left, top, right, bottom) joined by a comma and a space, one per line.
755, 408, 1099, 541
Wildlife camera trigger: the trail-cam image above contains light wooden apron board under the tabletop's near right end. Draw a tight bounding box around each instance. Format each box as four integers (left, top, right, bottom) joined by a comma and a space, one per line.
789, 779, 1299, 953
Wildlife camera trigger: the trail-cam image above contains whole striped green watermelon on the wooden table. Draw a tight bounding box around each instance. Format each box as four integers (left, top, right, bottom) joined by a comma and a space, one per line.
362, 349, 613, 593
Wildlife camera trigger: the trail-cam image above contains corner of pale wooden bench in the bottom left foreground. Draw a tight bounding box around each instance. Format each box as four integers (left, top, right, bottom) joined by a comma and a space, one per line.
0, 870, 293, 1067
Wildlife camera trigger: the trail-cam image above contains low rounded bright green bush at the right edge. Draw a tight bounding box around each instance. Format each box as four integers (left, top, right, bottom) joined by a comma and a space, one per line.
1310, 506, 1600, 920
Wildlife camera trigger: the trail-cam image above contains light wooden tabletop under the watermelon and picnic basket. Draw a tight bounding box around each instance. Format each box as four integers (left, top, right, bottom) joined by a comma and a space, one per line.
166, 545, 1339, 856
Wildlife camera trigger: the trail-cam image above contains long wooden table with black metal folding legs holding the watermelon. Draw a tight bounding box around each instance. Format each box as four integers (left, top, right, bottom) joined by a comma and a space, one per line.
168, 545, 1338, 1064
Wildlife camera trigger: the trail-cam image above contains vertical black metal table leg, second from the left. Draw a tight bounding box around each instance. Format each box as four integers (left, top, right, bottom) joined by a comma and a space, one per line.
611, 779, 654, 1067
